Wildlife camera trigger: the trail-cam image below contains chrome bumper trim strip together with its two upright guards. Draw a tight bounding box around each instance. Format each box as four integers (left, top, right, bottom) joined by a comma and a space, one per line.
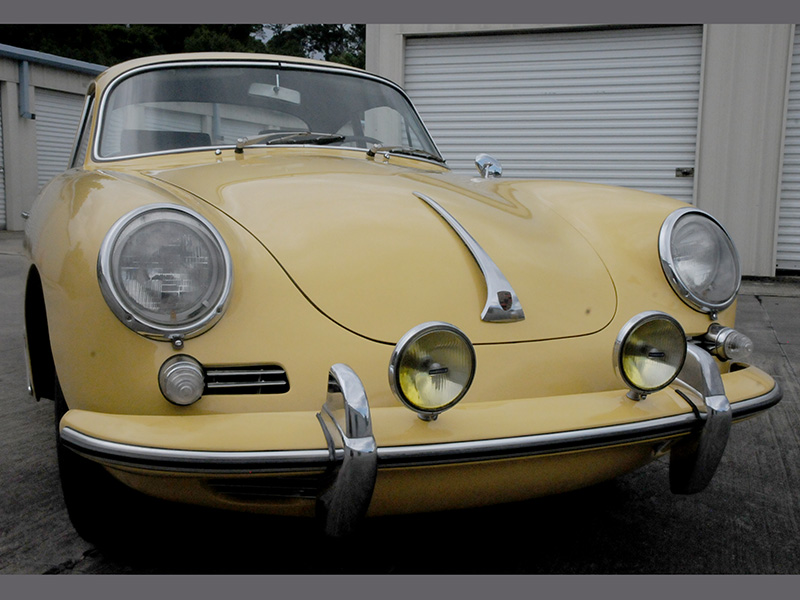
61, 345, 782, 536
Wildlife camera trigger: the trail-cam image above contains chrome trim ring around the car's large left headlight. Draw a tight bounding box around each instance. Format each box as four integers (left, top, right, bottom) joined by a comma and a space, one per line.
97, 203, 233, 343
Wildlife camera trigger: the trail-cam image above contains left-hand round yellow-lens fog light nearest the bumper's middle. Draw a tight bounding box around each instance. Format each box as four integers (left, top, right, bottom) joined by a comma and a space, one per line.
389, 322, 475, 420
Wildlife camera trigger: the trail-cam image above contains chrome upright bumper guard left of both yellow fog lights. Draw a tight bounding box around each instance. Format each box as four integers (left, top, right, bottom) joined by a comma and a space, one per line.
316, 364, 378, 537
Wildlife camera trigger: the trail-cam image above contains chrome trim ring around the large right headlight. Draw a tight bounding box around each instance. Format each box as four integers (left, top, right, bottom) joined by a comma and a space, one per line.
658, 207, 742, 318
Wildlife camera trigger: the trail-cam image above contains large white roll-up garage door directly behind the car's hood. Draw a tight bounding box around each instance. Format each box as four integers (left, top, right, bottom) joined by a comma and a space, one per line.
405, 26, 702, 202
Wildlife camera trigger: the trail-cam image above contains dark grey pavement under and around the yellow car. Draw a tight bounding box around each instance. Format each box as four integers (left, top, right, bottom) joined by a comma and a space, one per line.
0, 231, 800, 574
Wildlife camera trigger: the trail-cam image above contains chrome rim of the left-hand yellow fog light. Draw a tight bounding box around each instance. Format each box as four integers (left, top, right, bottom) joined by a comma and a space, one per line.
389, 321, 476, 421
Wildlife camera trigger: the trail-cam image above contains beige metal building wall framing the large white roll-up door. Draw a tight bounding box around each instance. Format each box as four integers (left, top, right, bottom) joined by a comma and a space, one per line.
367, 24, 795, 276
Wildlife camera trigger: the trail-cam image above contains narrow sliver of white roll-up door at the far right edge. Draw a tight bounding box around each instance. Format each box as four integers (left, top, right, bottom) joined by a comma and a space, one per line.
777, 28, 800, 271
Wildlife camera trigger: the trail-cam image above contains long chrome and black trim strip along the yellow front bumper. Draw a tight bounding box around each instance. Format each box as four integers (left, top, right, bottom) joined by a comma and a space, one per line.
61, 383, 783, 474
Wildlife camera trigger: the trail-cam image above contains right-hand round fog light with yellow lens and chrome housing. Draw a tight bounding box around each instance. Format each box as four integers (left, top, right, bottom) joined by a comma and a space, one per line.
614, 311, 687, 400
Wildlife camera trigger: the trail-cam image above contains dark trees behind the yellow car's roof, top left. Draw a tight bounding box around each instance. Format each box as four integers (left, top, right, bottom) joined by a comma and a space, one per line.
0, 24, 366, 67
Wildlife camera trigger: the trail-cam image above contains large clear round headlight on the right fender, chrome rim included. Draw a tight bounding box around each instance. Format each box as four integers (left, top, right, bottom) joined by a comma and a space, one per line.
659, 208, 741, 314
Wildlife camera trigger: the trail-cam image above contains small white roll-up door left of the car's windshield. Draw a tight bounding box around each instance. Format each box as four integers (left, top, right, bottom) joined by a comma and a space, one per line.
36, 88, 84, 188
